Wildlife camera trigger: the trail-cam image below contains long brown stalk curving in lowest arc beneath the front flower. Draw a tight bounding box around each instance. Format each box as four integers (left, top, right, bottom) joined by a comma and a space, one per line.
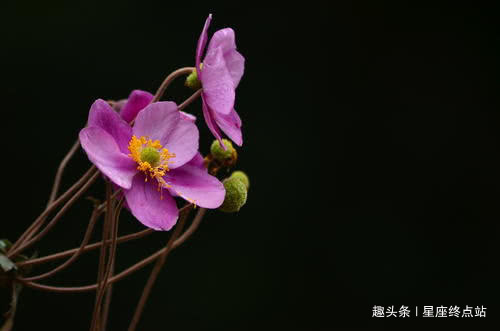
16, 208, 205, 293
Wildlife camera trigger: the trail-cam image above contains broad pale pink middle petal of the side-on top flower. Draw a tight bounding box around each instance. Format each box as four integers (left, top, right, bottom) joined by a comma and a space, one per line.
201, 47, 235, 114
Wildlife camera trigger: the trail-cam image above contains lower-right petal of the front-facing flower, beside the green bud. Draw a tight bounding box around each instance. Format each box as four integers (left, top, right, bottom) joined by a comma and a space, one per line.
164, 156, 226, 208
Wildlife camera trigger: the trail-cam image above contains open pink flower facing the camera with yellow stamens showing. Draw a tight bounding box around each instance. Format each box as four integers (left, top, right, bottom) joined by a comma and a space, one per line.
80, 99, 225, 230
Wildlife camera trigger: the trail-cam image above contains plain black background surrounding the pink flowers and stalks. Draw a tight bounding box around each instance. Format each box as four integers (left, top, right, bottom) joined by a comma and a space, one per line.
0, 1, 500, 330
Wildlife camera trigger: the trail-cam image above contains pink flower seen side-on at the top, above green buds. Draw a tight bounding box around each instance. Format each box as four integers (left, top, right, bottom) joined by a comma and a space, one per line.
196, 15, 245, 146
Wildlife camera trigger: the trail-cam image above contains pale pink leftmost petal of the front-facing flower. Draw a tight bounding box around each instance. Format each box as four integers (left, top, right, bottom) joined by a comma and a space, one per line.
80, 126, 137, 189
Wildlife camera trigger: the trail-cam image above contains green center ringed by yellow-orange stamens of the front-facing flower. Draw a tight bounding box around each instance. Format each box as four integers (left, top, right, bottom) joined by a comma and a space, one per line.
128, 136, 175, 189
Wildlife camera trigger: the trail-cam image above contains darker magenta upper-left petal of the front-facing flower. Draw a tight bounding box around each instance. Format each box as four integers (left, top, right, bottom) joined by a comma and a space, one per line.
88, 99, 132, 154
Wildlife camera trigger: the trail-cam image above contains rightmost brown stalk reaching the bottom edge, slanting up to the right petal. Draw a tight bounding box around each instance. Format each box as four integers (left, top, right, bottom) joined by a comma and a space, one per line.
128, 211, 193, 331
